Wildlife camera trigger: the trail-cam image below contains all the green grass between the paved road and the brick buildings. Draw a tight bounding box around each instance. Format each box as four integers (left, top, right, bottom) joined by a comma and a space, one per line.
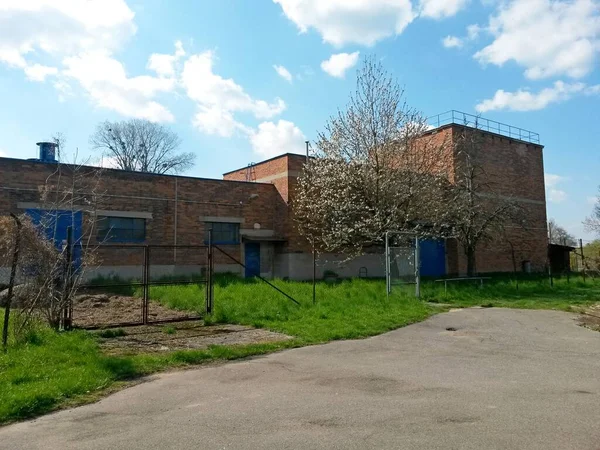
0, 277, 600, 423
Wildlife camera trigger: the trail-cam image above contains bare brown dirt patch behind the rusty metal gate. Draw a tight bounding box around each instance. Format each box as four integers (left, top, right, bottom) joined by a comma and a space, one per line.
73, 293, 199, 328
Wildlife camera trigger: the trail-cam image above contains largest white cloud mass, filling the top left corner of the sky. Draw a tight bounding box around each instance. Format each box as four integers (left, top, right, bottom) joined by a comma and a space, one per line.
0, 0, 183, 122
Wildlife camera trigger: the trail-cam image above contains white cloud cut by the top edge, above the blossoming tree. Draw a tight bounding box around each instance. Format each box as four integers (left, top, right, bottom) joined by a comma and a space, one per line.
273, 0, 415, 47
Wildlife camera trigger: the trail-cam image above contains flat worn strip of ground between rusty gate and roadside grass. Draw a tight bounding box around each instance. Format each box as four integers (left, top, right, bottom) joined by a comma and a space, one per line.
98, 322, 292, 353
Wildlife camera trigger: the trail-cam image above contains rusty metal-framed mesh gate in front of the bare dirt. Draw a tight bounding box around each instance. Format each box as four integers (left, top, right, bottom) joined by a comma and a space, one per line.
75, 244, 214, 328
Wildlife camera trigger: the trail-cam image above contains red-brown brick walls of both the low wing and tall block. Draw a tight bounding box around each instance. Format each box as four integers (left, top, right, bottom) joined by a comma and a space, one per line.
0, 125, 547, 275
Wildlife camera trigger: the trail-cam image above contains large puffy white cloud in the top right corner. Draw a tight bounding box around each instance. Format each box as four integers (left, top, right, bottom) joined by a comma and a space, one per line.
474, 0, 600, 79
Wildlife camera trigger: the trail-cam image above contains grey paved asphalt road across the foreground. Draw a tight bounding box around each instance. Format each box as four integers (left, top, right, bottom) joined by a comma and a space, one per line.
0, 309, 600, 450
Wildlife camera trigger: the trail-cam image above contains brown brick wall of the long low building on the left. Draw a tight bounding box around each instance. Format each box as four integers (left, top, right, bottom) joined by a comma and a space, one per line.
0, 158, 285, 264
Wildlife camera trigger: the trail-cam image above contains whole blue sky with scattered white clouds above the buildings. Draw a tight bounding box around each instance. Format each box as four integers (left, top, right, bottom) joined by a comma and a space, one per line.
0, 0, 600, 239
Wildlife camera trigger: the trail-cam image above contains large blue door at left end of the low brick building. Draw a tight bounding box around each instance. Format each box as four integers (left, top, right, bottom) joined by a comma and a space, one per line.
25, 209, 83, 267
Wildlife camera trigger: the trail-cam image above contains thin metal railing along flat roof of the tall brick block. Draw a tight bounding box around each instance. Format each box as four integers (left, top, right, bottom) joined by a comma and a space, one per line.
427, 109, 540, 144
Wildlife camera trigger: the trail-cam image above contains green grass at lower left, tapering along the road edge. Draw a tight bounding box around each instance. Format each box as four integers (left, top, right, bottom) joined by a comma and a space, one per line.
0, 312, 284, 424
